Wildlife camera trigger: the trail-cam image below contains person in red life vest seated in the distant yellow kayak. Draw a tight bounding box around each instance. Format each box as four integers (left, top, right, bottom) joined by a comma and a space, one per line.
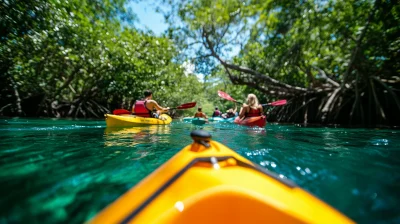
132, 90, 169, 120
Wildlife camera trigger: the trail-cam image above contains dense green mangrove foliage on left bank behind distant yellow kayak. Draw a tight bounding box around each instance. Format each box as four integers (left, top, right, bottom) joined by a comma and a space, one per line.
0, 0, 206, 117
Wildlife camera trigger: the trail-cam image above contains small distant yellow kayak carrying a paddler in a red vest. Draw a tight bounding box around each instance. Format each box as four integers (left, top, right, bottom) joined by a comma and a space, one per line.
104, 114, 172, 127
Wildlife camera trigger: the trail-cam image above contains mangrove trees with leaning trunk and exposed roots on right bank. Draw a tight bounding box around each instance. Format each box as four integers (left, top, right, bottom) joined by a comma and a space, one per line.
162, 0, 400, 124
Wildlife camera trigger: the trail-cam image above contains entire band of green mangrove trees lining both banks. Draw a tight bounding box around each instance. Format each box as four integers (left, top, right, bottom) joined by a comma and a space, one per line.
0, 0, 400, 127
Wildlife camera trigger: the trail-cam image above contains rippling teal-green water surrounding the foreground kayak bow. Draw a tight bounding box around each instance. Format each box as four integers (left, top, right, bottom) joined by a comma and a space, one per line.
0, 119, 400, 223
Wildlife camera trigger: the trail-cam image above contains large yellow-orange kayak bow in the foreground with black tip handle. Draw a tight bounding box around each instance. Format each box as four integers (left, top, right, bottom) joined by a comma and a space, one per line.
89, 130, 354, 224
